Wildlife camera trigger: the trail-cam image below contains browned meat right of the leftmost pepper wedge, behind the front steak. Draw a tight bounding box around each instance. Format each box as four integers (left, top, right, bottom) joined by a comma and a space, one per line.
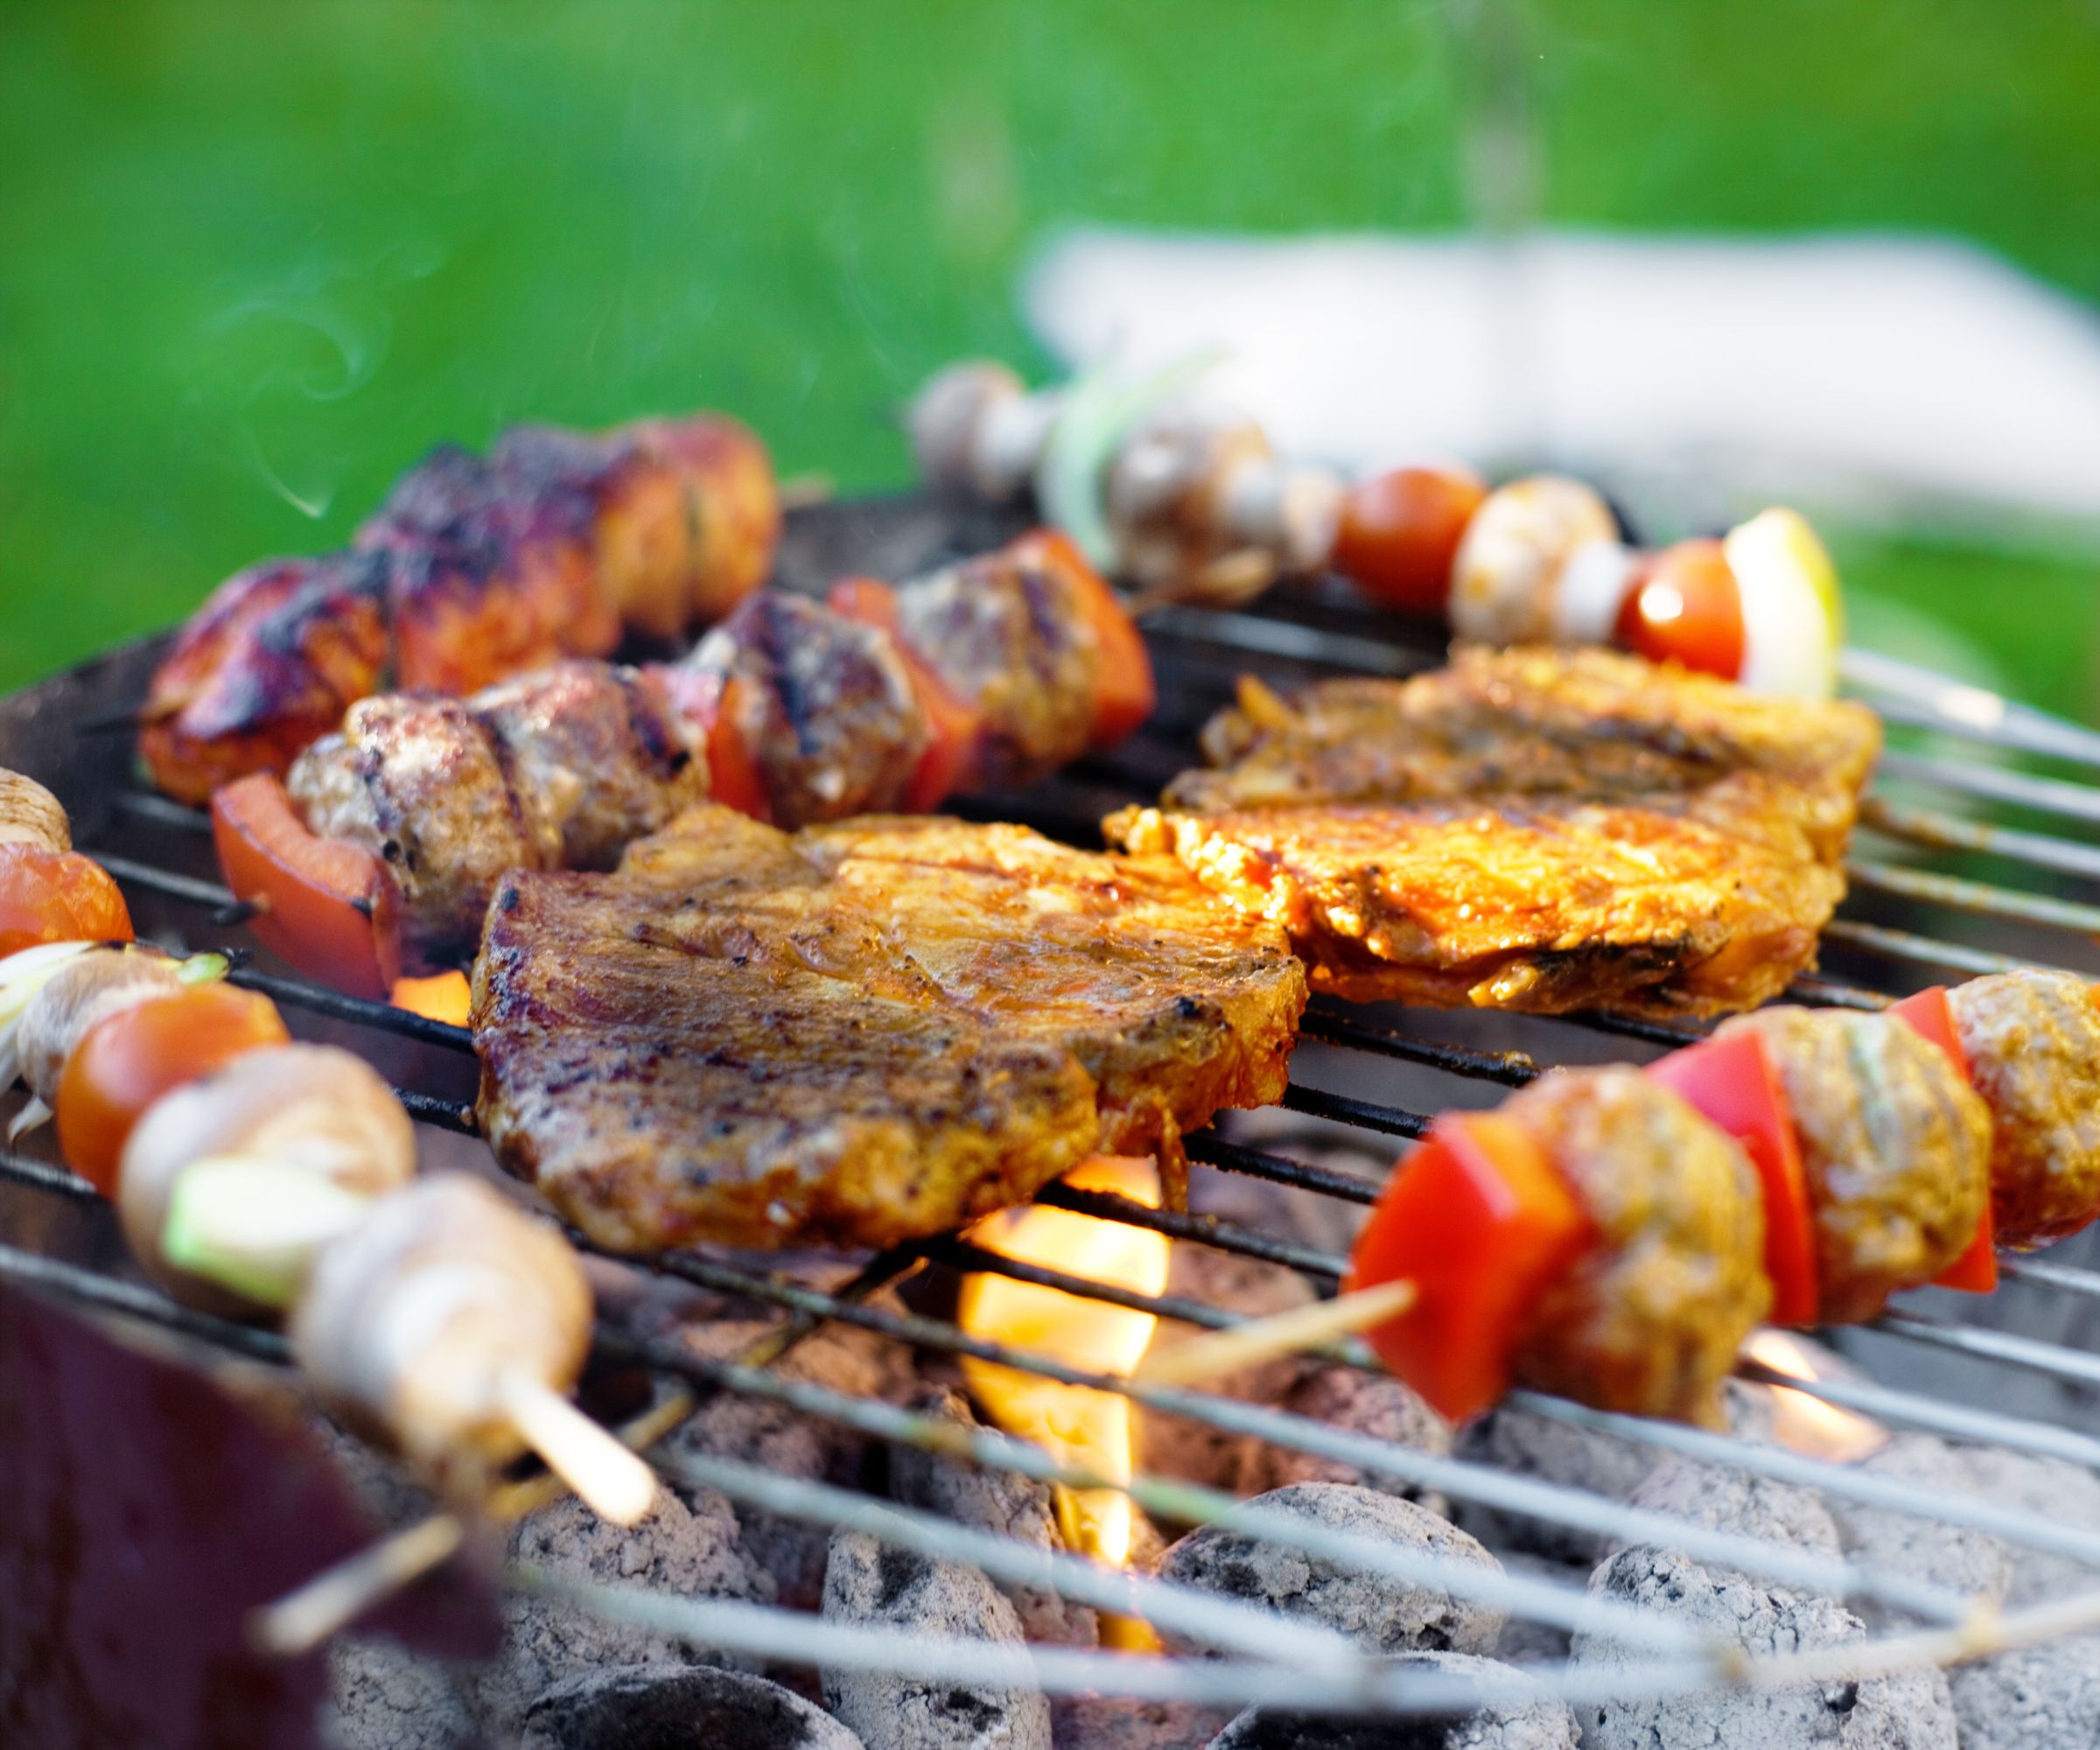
288, 660, 708, 964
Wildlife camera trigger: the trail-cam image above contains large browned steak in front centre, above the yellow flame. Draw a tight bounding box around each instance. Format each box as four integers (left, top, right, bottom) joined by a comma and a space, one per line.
472, 807, 1306, 1250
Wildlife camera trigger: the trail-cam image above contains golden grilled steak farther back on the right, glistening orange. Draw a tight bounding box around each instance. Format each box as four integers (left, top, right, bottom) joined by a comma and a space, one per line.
1107, 649, 1880, 1015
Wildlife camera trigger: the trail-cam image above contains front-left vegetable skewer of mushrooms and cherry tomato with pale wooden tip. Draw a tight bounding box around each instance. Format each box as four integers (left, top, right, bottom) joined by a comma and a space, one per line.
0, 774, 653, 1521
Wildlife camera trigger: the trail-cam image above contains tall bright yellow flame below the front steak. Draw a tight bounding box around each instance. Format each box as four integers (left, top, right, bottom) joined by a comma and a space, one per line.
957, 1156, 1167, 1565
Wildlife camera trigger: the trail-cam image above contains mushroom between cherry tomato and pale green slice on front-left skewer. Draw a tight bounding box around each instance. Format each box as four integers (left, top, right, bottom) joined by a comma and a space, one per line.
117, 1044, 416, 1315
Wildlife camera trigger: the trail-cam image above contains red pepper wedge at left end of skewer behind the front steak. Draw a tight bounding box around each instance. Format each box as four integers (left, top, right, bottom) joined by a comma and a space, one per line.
212, 771, 401, 1002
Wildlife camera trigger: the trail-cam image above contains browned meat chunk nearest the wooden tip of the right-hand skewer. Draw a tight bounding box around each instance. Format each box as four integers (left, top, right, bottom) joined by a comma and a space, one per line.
1503, 1068, 1773, 1422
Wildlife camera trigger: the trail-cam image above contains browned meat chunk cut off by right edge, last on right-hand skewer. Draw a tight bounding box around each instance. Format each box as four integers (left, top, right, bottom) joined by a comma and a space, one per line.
1947, 973, 2100, 1246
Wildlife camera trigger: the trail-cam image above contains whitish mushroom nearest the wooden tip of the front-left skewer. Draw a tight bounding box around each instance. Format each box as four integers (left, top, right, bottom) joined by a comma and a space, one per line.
292, 1174, 592, 1485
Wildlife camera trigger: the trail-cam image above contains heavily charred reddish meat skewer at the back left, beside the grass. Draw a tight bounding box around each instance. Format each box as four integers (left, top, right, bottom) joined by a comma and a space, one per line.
138, 414, 779, 802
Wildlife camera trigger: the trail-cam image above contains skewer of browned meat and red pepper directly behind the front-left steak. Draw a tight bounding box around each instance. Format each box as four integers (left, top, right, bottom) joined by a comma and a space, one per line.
212, 534, 1153, 996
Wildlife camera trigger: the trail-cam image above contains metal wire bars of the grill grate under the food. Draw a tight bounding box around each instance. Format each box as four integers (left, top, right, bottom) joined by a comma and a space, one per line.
12, 575, 2100, 1717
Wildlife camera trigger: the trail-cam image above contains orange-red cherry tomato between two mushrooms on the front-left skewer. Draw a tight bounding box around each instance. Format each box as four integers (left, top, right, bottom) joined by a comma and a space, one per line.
54, 985, 292, 1198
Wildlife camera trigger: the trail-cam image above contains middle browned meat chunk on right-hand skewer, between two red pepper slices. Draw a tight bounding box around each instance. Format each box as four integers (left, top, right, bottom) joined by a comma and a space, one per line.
1722, 1006, 1991, 1324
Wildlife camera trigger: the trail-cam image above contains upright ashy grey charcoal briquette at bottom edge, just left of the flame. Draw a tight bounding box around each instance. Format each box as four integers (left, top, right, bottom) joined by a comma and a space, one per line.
823, 1531, 1050, 1750
